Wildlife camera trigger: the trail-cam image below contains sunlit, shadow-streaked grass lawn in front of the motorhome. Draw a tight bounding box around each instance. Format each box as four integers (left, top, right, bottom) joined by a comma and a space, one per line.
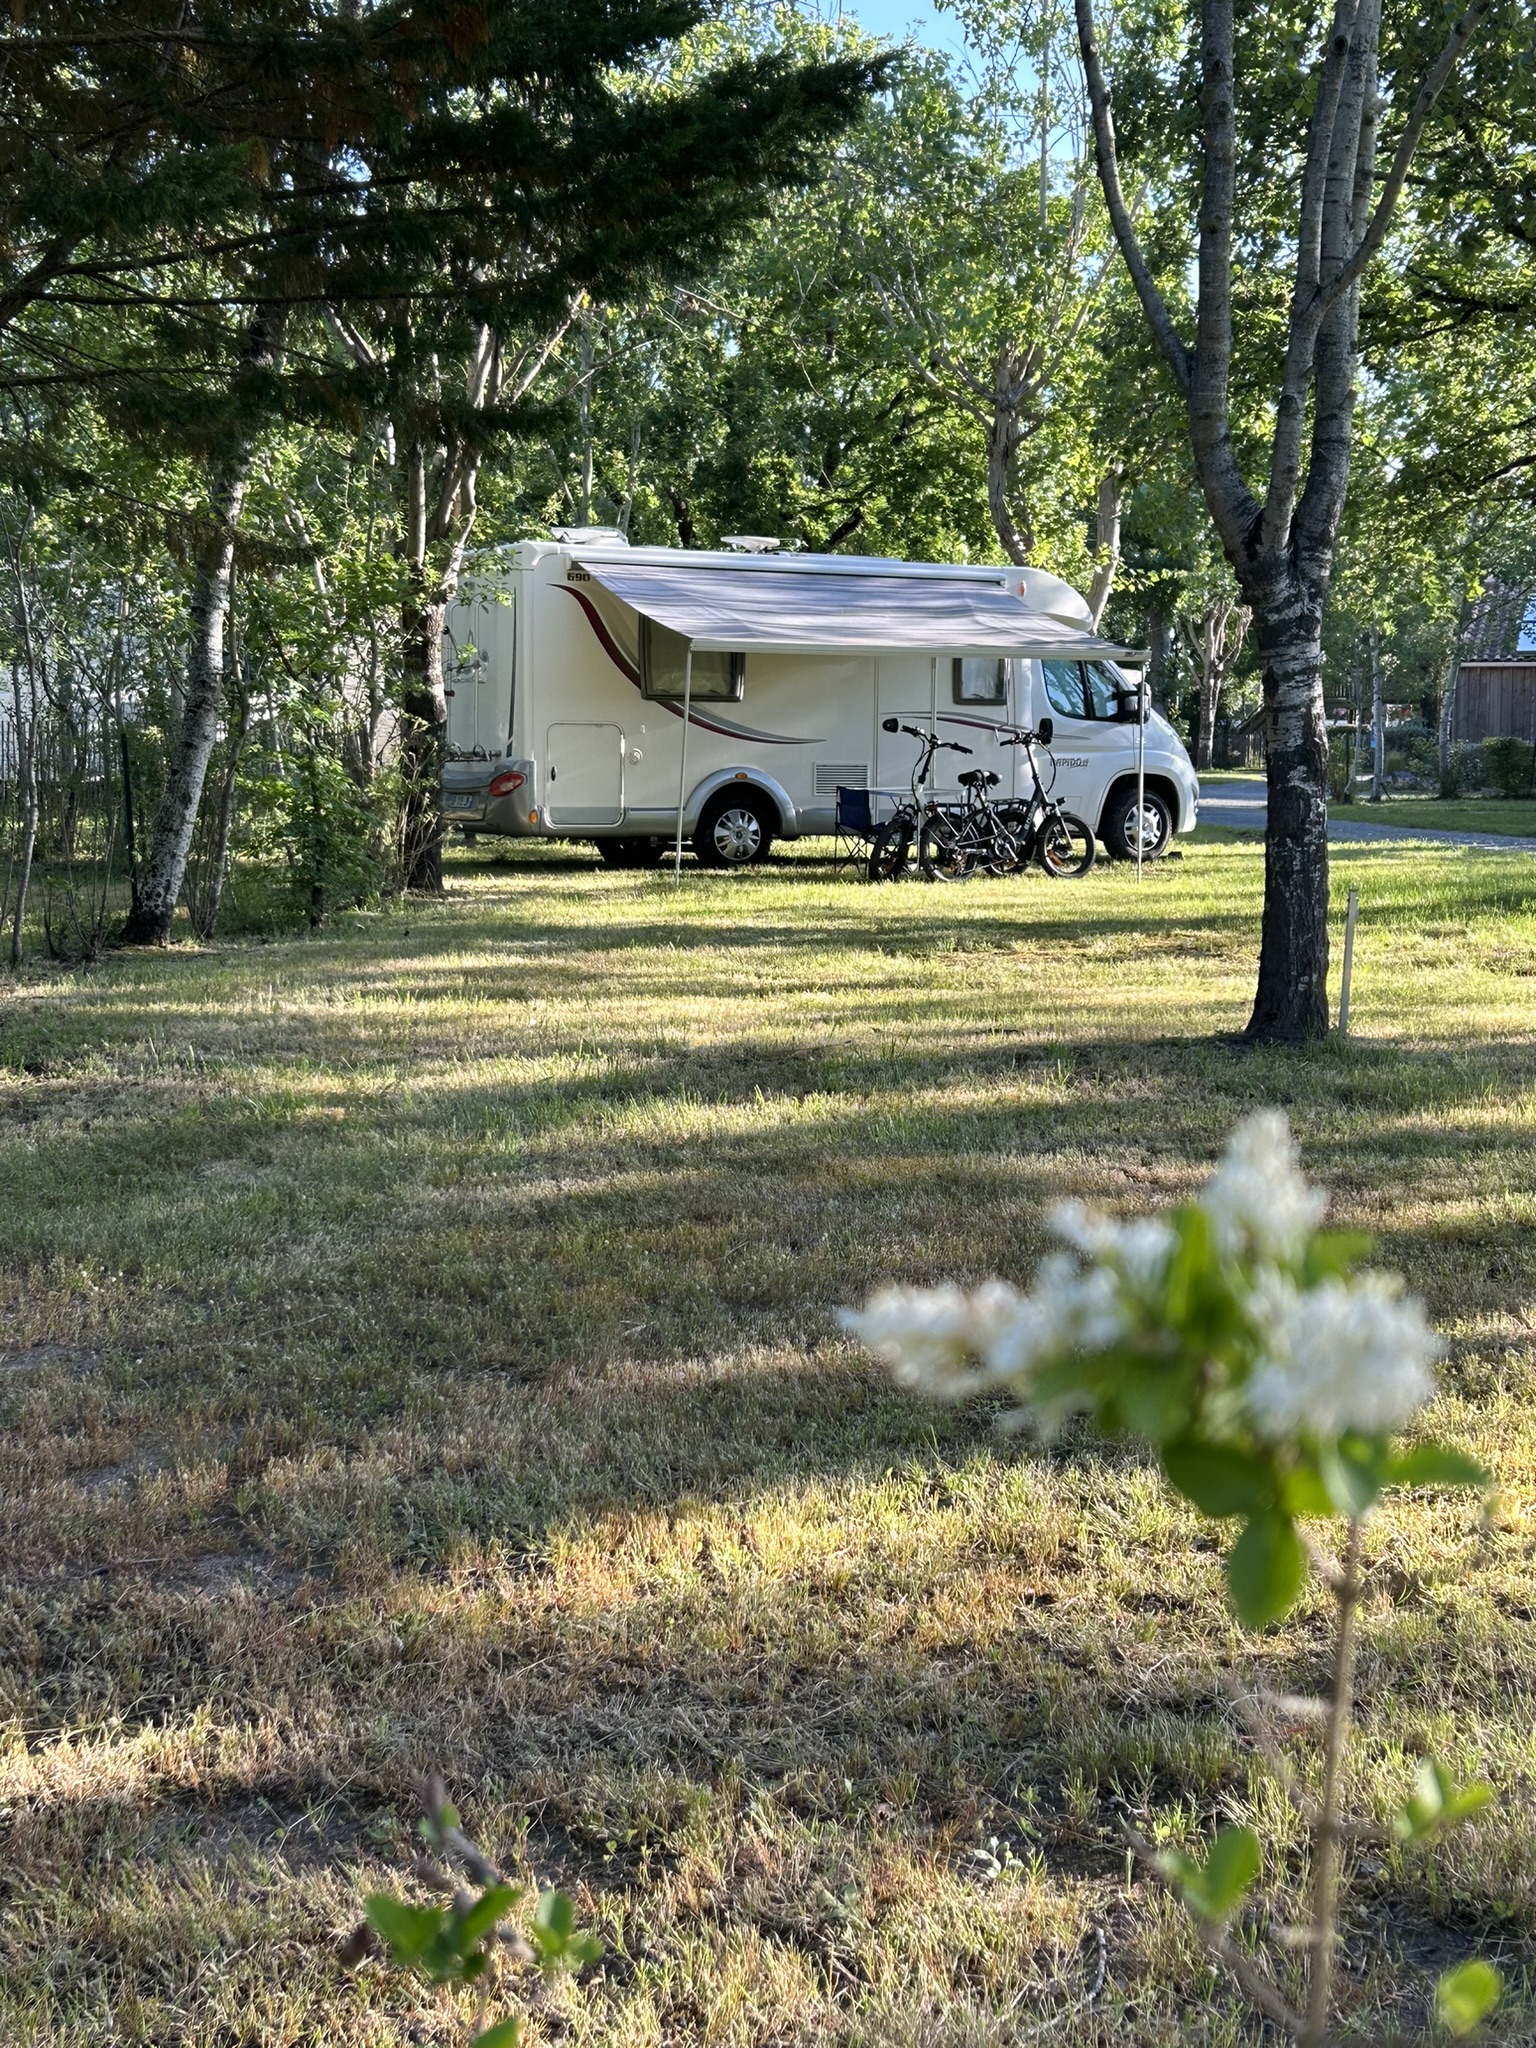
0, 844, 1536, 2048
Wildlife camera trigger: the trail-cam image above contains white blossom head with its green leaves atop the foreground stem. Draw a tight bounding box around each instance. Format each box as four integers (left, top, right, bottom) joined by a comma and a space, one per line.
844, 1110, 1487, 1628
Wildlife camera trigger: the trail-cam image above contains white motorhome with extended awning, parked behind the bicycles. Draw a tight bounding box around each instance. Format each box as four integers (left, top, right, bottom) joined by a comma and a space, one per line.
444, 541, 1198, 862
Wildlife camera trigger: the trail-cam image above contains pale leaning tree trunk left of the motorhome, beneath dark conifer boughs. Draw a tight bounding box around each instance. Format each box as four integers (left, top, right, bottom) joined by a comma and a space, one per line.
121, 305, 287, 946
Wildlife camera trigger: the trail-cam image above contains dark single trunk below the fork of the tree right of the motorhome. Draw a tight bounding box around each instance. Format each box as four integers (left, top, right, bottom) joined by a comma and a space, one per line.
1243, 567, 1327, 1044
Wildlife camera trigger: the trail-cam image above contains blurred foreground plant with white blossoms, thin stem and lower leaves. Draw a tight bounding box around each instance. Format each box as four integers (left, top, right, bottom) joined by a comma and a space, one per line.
844, 1110, 1499, 2044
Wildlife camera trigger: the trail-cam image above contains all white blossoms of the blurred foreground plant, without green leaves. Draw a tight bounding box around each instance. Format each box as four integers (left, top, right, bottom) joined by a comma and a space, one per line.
842, 1110, 1440, 1442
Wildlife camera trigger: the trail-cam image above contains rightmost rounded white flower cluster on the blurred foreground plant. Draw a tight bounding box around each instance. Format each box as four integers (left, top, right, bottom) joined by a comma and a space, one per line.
1243, 1272, 1444, 1444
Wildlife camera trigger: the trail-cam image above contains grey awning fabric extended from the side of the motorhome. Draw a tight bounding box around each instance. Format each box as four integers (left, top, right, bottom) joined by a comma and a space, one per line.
580, 555, 1133, 662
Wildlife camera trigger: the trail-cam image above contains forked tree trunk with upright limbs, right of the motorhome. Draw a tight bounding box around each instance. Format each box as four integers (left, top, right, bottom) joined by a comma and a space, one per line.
1075, 0, 1491, 1042
